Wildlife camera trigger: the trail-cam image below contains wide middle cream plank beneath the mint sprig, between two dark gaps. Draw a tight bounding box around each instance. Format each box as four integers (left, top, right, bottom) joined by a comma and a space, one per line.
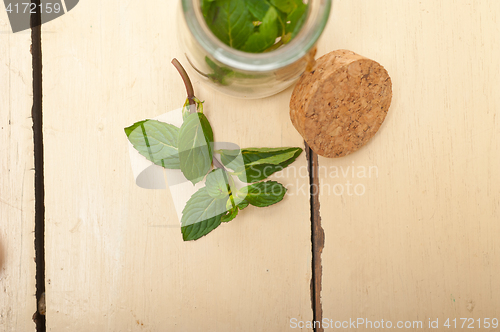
42, 0, 312, 332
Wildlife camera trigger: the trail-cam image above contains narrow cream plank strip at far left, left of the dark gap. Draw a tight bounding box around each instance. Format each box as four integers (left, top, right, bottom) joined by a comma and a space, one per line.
0, 10, 36, 332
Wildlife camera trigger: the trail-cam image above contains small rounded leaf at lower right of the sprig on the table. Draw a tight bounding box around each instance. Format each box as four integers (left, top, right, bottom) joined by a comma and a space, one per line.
239, 181, 286, 207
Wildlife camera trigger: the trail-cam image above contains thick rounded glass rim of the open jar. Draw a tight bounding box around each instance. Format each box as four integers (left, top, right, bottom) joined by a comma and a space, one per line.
181, 0, 332, 72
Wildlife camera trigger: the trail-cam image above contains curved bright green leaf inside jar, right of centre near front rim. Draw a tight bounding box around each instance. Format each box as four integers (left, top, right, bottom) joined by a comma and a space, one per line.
242, 7, 278, 53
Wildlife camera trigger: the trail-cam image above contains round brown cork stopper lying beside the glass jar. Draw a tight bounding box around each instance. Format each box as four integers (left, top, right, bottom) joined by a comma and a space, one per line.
290, 50, 392, 158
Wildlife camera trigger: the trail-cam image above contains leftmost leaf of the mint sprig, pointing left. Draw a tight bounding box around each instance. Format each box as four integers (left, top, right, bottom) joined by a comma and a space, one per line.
125, 120, 180, 169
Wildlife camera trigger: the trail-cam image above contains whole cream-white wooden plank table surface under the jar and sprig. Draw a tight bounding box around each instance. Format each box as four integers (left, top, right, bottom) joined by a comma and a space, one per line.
0, 0, 500, 332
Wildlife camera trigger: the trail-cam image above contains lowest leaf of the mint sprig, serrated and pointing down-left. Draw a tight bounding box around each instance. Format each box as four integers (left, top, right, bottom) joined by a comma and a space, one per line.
181, 187, 228, 241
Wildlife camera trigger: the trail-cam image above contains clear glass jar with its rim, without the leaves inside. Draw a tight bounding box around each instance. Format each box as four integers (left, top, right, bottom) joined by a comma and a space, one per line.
177, 0, 331, 99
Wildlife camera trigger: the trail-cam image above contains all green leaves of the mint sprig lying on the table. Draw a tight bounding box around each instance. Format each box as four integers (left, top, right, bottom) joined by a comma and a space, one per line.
125, 104, 302, 241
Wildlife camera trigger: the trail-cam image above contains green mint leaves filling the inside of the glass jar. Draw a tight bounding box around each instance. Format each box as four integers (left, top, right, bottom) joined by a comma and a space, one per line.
201, 0, 307, 53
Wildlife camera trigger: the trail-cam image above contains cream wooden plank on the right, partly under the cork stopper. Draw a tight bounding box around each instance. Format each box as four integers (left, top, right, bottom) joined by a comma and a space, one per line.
318, 0, 500, 331
